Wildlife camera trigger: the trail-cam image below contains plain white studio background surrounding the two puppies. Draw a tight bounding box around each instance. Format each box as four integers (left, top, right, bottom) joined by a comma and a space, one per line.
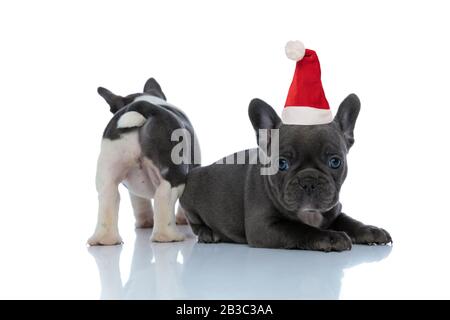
0, 0, 450, 298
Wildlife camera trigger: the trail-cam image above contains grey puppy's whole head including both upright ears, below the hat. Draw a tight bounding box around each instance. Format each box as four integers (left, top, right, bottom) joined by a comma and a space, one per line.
249, 94, 360, 217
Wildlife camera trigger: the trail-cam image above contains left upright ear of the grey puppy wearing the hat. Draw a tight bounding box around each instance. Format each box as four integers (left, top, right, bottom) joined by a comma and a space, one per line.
248, 99, 281, 147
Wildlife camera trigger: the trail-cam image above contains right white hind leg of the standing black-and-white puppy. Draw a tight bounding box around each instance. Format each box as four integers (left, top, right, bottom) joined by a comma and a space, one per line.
151, 179, 184, 242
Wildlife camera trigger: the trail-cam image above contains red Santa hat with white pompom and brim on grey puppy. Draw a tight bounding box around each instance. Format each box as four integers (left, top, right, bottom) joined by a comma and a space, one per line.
281, 41, 333, 125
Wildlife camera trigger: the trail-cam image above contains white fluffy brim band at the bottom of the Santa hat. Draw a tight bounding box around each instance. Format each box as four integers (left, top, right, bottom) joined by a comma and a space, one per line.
281, 107, 333, 125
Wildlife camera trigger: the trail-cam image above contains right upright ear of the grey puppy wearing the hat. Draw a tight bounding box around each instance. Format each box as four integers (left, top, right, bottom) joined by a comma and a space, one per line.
334, 93, 361, 149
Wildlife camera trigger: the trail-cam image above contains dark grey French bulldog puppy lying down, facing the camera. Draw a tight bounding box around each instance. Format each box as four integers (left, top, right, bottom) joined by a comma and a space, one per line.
180, 94, 392, 251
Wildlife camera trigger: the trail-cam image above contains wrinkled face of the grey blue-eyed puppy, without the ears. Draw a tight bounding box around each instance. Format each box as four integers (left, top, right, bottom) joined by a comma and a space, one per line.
267, 123, 347, 213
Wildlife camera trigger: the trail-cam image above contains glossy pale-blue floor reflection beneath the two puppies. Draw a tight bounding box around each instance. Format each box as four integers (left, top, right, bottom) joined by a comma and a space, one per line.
88, 227, 392, 299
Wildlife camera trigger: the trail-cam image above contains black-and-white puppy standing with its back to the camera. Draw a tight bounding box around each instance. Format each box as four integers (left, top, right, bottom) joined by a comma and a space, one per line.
88, 78, 200, 245
